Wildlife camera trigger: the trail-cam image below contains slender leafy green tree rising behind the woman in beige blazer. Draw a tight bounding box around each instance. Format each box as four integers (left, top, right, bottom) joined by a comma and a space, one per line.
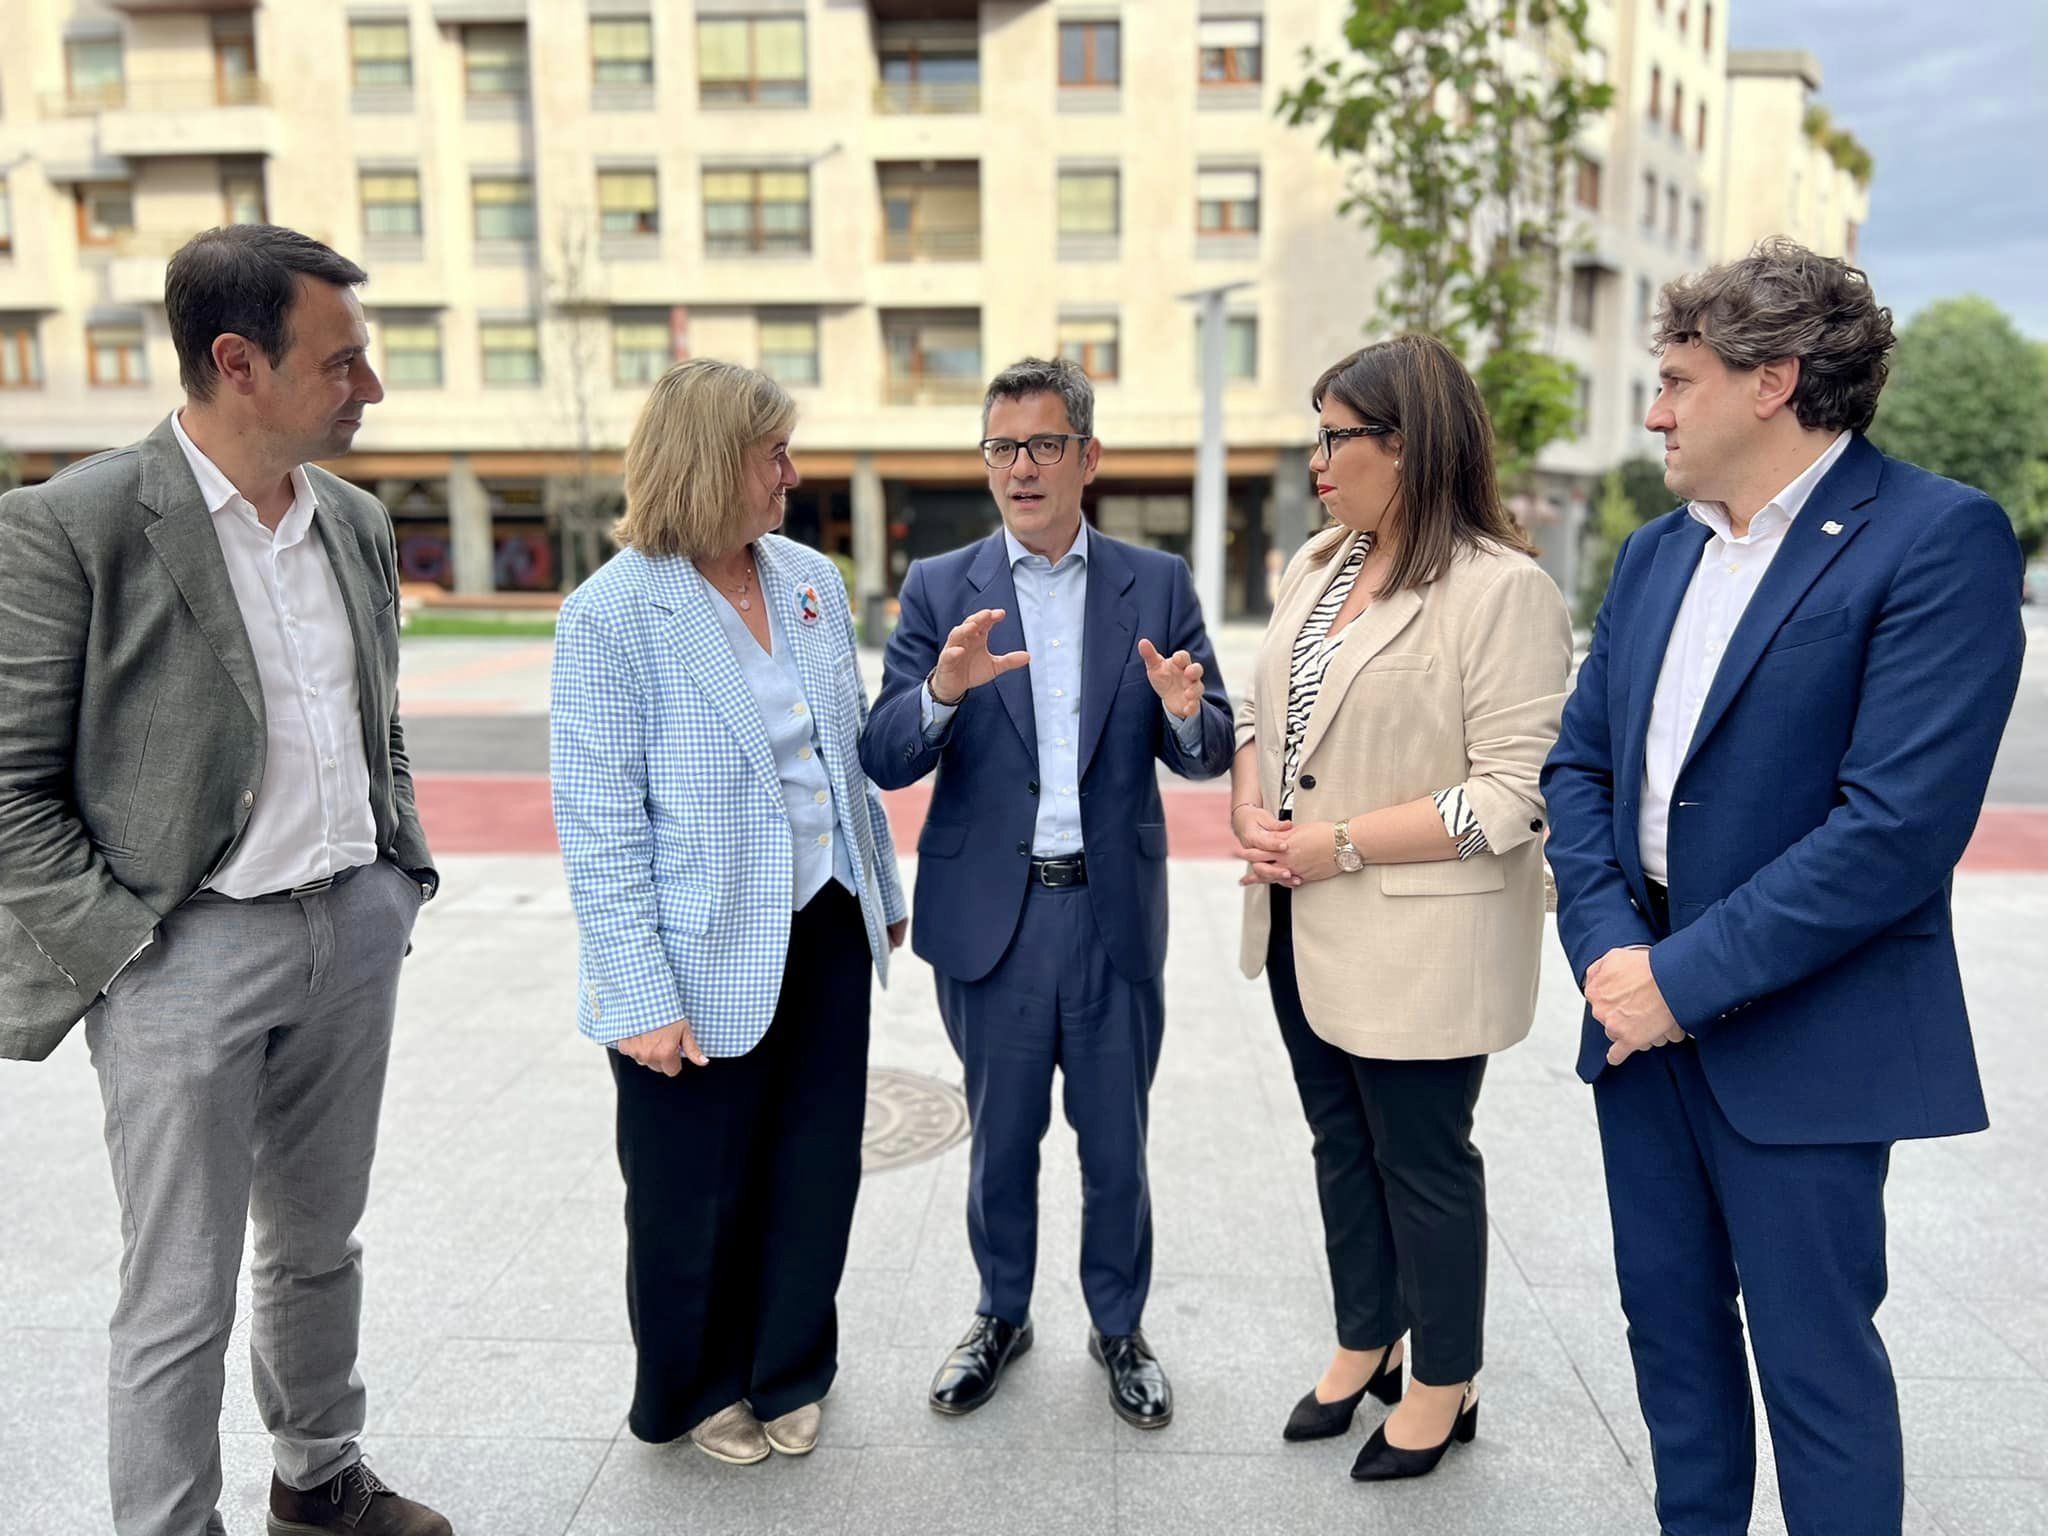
1280, 0, 1614, 485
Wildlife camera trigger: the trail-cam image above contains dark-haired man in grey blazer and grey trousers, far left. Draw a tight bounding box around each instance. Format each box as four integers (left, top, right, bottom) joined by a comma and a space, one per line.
0, 225, 451, 1536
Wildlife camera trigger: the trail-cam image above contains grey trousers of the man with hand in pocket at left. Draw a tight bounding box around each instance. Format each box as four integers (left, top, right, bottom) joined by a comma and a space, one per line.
86, 862, 420, 1536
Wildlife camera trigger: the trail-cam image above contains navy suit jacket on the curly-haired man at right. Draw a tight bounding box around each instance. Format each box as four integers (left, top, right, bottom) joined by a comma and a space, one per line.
1542, 436, 2025, 1145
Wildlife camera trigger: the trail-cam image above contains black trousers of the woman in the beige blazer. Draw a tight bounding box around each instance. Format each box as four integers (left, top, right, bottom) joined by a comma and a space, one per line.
1266, 885, 1487, 1386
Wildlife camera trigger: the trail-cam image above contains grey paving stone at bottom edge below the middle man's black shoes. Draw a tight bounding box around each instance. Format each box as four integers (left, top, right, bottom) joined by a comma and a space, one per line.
844, 1448, 1116, 1536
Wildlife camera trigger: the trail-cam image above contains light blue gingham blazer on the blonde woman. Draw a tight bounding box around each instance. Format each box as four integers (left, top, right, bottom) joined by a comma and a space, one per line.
549, 535, 905, 1057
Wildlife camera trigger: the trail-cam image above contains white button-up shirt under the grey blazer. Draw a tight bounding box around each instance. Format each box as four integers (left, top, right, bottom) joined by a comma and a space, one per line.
170, 414, 377, 897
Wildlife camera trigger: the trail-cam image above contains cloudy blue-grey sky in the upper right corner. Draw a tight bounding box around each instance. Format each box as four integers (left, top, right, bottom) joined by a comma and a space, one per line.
1729, 0, 2048, 340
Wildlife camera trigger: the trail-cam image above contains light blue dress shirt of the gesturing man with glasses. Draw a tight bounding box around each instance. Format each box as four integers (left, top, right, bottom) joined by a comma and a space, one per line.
925, 518, 1202, 858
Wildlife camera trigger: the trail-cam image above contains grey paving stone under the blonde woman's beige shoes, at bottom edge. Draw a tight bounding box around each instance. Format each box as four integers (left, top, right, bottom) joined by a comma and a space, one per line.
569, 1440, 862, 1536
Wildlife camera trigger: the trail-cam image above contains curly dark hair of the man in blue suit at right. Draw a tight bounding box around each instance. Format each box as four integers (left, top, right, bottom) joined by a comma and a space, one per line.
1651, 236, 1892, 432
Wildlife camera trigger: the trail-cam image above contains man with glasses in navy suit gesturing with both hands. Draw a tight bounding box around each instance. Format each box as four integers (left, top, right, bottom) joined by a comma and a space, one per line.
860, 358, 1231, 1430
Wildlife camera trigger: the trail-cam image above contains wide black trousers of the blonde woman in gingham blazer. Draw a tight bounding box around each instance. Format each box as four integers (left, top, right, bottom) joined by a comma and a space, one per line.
610, 881, 870, 1442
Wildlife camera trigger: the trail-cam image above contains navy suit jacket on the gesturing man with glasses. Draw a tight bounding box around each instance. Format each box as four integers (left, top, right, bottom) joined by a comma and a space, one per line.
860, 528, 1231, 981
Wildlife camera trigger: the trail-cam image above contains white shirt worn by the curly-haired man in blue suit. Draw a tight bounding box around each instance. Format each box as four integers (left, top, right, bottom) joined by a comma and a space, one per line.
1636, 432, 1849, 885
